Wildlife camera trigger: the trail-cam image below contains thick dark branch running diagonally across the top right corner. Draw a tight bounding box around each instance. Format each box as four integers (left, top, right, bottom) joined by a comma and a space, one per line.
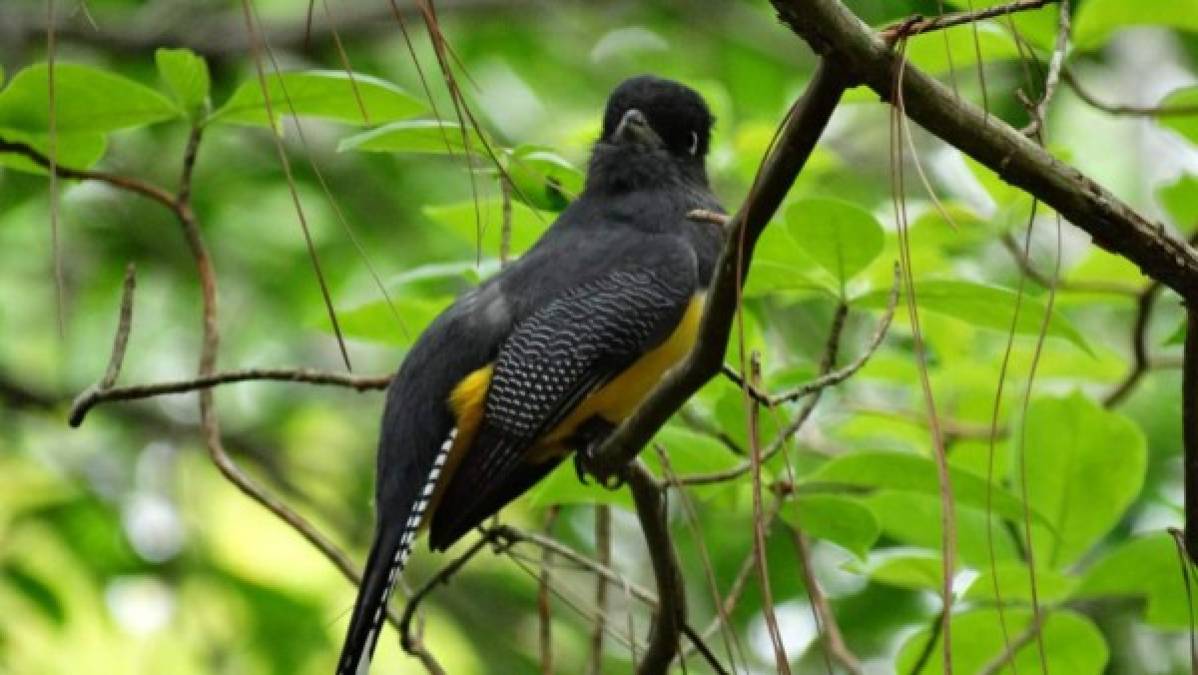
772, 0, 1198, 297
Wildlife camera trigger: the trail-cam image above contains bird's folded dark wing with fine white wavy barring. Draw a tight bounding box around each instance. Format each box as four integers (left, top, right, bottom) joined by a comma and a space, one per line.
430, 255, 697, 549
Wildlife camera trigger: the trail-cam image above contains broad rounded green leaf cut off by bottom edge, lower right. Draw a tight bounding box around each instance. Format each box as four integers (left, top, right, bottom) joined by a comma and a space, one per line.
896, 608, 1109, 675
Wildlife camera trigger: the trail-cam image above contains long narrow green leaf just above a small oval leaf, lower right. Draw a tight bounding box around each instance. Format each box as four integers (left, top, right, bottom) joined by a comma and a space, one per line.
803, 452, 1039, 522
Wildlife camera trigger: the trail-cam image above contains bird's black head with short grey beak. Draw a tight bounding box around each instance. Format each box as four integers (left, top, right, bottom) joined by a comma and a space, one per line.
587, 76, 715, 189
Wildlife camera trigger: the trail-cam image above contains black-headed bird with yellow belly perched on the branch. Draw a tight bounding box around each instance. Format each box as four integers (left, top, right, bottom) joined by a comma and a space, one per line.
335, 74, 724, 675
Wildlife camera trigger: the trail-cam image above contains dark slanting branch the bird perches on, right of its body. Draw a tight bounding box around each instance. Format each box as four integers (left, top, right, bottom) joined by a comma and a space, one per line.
588, 61, 846, 480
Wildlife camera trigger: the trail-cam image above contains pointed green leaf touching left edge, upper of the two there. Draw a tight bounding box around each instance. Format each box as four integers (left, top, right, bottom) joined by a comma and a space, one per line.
0, 64, 180, 134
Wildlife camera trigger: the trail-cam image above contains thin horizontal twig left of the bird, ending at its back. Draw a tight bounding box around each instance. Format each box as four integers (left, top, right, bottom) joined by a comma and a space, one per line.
68, 368, 392, 427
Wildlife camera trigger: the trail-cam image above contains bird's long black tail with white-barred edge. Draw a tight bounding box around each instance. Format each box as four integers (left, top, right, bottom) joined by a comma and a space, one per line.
337, 429, 458, 675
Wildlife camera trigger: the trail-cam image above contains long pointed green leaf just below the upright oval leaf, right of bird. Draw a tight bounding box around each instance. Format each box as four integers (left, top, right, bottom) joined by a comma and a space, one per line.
853, 279, 1093, 354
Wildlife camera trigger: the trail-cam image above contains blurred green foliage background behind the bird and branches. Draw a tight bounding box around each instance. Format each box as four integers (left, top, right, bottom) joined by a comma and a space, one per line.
0, 0, 1198, 675
